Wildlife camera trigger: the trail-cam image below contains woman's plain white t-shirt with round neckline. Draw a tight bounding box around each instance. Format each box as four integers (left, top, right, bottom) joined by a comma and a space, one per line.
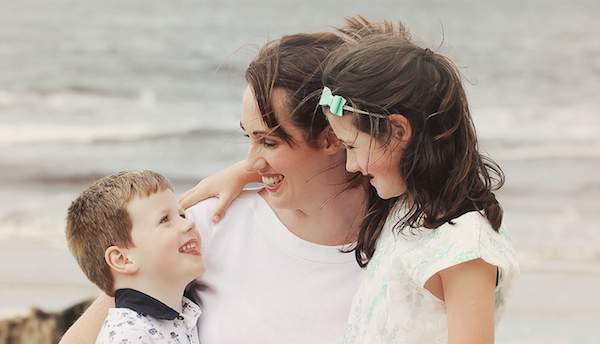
186, 191, 360, 344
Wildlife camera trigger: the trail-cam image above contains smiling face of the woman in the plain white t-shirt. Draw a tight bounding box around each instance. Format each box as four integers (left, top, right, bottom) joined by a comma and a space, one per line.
241, 87, 344, 209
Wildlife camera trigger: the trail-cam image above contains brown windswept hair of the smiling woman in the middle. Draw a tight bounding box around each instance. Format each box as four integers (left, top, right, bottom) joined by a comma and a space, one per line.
245, 32, 343, 147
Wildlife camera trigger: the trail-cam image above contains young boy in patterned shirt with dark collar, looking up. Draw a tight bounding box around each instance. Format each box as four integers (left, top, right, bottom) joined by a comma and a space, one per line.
66, 171, 205, 343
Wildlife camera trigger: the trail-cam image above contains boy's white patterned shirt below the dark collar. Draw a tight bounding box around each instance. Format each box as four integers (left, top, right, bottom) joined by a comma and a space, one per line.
96, 297, 200, 344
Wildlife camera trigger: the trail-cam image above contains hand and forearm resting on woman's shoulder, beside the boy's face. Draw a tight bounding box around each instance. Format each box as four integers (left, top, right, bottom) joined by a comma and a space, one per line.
179, 161, 261, 223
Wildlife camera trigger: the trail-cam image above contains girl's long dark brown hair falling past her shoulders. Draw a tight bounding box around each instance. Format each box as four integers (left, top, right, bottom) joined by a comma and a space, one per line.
323, 17, 504, 266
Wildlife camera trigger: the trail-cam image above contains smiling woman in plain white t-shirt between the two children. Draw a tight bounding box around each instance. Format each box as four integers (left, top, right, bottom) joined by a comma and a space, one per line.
61, 33, 367, 344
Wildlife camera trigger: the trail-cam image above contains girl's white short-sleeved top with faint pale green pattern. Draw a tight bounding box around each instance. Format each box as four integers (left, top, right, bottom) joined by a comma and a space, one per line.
344, 211, 519, 344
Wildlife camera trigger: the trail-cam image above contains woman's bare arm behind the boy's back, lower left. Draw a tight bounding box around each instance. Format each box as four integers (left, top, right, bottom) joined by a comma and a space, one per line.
59, 294, 115, 344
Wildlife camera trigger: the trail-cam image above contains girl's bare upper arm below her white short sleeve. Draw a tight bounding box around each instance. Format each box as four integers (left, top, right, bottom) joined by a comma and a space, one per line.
438, 258, 497, 344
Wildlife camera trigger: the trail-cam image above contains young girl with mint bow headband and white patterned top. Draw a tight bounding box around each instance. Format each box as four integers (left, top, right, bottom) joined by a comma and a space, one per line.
320, 17, 519, 344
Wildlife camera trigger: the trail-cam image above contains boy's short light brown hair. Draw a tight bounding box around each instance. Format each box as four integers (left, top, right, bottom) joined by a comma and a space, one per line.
66, 170, 173, 296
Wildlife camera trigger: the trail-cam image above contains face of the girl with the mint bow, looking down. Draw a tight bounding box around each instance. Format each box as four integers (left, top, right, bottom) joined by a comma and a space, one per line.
324, 109, 406, 199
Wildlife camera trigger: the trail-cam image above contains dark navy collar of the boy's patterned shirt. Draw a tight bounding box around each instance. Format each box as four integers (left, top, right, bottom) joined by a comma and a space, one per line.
115, 288, 179, 320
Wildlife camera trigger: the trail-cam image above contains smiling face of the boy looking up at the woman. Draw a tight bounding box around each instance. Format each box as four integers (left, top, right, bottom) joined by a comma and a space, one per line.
127, 189, 205, 285
